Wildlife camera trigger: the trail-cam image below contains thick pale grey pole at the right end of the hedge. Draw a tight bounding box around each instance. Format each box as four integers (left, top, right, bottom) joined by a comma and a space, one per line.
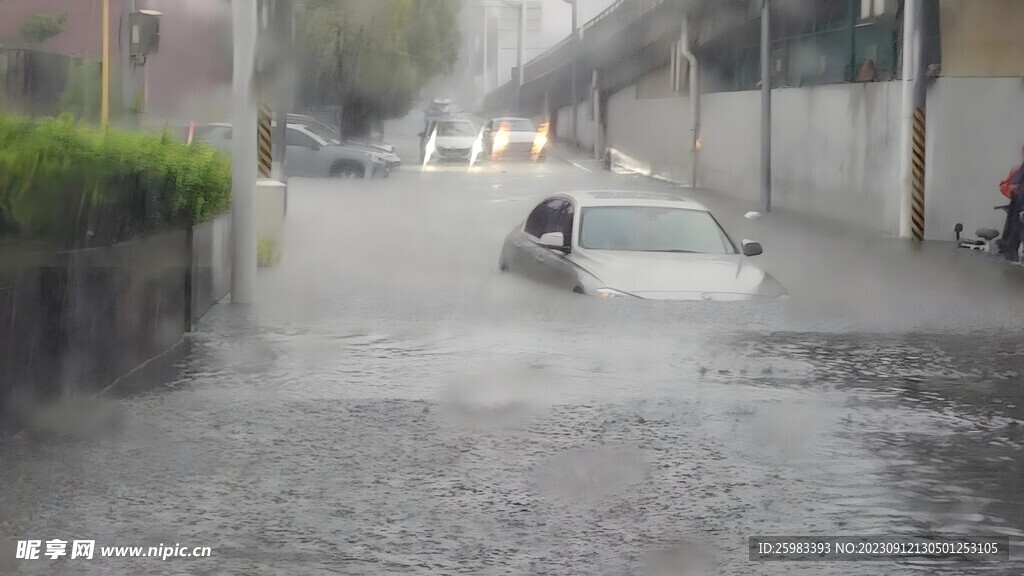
231, 0, 257, 304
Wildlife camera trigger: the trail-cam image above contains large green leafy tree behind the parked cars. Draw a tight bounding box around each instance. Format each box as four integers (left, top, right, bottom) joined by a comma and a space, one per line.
298, 0, 459, 137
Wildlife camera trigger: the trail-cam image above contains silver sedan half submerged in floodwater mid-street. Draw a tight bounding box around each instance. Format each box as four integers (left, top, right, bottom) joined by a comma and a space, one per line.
499, 191, 786, 300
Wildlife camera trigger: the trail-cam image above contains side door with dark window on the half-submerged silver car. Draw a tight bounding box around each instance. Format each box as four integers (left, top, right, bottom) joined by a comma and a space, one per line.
512, 197, 575, 288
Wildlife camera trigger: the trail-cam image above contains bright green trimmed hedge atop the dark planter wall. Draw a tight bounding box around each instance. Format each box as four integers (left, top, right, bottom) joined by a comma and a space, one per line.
0, 112, 231, 245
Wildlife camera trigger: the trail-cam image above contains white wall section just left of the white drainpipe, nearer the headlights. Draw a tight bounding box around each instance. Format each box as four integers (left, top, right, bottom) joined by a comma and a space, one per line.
605, 84, 691, 182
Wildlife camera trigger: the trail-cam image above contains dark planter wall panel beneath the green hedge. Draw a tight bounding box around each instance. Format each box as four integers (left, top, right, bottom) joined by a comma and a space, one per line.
0, 230, 190, 431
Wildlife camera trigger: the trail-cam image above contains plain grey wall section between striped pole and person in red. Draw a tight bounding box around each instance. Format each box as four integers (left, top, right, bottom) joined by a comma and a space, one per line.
925, 78, 1024, 240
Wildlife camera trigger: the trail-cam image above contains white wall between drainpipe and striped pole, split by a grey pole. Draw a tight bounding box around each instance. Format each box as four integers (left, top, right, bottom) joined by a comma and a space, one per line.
700, 82, 900, 235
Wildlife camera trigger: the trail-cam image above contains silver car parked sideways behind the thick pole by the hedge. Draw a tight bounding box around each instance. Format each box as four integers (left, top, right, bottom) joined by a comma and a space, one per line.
196, 123, 388, 178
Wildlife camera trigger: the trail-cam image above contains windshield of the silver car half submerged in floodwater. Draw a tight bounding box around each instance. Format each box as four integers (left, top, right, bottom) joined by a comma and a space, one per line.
580, 206, 735, 254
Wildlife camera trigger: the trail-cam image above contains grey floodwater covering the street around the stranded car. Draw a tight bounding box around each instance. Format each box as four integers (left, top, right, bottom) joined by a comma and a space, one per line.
0, 130, 1024, 576
